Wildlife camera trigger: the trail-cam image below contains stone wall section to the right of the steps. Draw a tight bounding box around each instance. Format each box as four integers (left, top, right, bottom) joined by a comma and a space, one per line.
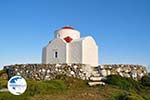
99, 64, 148, 80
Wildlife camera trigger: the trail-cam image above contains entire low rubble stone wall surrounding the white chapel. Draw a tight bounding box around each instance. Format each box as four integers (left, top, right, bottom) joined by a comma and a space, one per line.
4, 64, 147, 80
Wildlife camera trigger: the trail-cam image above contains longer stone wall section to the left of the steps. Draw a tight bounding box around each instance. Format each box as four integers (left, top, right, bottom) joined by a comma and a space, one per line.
4, 64, 92, 80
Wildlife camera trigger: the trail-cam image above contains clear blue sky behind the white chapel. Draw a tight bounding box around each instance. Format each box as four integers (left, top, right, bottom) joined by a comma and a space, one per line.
0, 0, 150, 68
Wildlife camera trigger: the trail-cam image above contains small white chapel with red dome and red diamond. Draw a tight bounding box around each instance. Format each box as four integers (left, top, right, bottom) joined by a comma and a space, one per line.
42, 26, 98, 66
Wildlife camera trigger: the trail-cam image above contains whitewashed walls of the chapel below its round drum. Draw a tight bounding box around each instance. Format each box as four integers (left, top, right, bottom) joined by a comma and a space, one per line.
42, 36, 98, 66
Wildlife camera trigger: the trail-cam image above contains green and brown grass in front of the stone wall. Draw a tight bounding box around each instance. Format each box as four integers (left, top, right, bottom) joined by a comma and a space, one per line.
0, 73, 150, 100
